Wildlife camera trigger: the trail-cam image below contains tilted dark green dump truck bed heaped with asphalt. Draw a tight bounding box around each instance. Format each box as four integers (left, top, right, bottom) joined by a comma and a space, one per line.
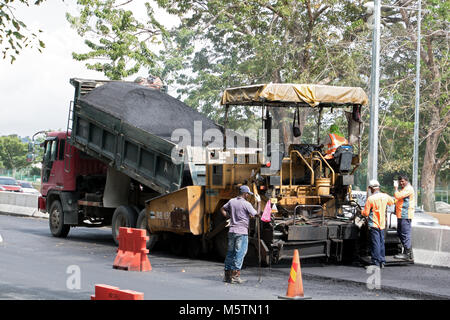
69, 79, 221, 194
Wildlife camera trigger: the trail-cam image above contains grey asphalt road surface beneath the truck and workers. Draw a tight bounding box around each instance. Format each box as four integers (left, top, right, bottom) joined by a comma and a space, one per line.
0, 215, 450, 301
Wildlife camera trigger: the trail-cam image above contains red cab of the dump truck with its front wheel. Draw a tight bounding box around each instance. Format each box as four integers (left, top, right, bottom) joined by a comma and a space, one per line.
38, 132, 110, 237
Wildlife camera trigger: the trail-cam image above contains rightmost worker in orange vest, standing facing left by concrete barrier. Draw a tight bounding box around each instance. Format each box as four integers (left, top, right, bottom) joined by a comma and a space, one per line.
394, 175, 415, 262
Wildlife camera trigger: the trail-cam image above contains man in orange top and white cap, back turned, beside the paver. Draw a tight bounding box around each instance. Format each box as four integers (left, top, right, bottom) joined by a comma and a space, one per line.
361, 180, 394, 268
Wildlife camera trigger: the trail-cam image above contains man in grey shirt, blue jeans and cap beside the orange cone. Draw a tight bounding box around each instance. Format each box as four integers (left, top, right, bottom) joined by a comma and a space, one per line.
220, 185, 261, 283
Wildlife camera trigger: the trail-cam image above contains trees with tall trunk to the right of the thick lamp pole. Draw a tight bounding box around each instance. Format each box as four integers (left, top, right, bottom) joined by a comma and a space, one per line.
366, 0, 450, 211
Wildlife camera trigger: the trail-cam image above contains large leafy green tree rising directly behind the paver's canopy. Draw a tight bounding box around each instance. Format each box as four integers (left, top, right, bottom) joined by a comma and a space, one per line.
158, 0, 369, 146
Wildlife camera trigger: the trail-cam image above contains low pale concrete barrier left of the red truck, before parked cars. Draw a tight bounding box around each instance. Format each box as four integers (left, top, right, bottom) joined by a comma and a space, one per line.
0, 191, 48, 217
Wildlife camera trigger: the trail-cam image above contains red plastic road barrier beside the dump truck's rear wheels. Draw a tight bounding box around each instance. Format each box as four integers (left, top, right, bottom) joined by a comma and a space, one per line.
113, 227, 152, 271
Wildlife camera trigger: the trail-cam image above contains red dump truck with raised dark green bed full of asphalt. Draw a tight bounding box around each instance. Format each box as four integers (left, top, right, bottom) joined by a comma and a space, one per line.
38, 78, 218, 243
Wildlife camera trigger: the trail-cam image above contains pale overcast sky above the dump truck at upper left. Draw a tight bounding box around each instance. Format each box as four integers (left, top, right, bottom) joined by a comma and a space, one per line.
0, 0, 176, 137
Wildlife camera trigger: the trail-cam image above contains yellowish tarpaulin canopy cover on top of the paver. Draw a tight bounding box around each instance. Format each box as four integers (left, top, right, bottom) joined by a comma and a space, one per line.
221, 83, 368, 107
